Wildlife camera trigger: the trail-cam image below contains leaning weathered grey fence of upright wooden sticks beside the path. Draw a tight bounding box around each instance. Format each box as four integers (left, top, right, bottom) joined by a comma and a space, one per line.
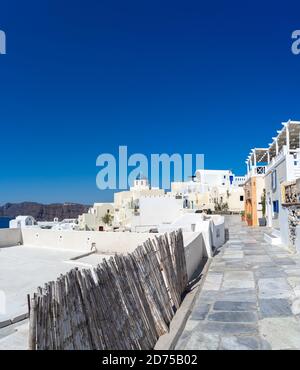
29, 230, 188, 350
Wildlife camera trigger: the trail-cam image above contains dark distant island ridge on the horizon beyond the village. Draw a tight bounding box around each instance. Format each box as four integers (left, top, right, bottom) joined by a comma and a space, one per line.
0, 202, 90, 221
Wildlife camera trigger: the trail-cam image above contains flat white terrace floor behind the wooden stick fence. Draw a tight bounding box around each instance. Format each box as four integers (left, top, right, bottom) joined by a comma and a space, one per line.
0, 245, 110, 350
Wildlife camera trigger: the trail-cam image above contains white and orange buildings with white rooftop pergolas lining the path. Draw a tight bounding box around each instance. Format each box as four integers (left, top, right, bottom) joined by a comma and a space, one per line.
245, 120, 300, 250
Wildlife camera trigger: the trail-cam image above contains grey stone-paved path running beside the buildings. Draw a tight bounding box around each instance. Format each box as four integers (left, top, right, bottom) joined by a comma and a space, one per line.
176, 216, 300, 350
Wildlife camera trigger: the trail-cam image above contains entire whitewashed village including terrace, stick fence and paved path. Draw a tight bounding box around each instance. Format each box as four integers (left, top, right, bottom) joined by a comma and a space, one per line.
0, 120, 300, 350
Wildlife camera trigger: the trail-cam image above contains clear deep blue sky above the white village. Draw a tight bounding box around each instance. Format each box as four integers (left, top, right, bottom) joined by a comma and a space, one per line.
0, 0, 300, 203
